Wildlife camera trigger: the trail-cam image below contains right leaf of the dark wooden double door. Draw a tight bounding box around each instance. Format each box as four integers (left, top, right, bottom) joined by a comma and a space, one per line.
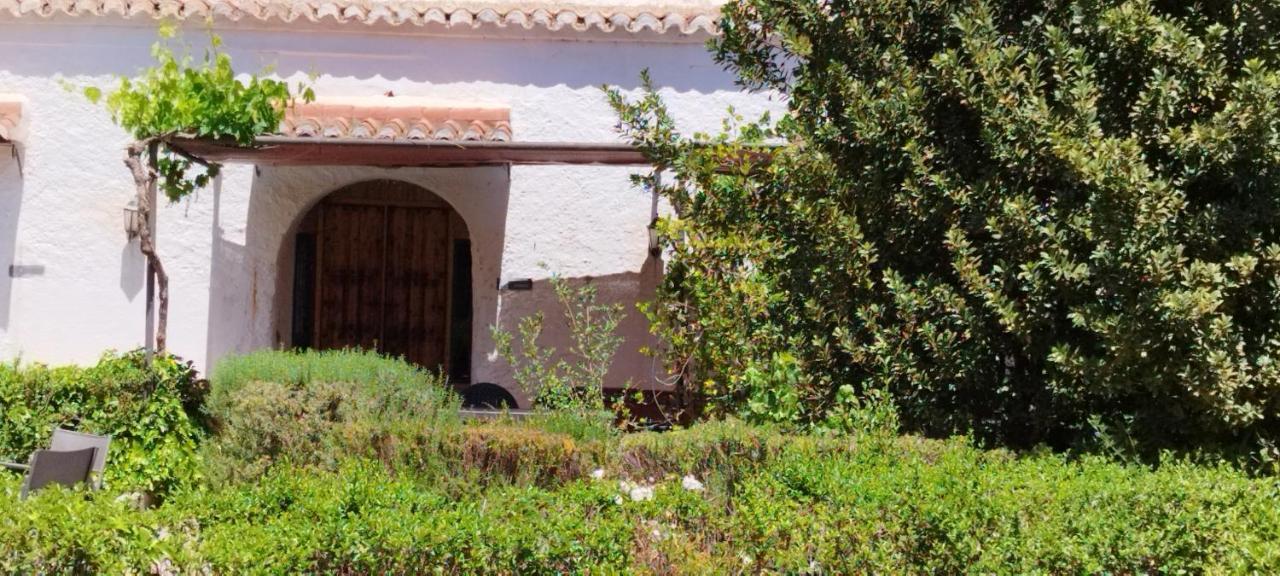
384, 206, 449, 370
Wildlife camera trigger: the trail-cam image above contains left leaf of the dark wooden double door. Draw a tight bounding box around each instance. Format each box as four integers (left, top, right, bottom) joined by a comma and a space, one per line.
315, 204, 387, 349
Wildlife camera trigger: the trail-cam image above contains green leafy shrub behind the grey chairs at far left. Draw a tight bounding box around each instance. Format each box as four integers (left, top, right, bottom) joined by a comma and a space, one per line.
0, 351, 204, 495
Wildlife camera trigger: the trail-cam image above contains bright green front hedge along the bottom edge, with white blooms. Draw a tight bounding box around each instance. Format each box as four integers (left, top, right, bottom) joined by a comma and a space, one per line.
0, 424, 1280, 575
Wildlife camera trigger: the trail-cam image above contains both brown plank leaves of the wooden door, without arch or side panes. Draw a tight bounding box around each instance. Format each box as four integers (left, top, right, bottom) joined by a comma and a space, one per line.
315, 204, 449, 370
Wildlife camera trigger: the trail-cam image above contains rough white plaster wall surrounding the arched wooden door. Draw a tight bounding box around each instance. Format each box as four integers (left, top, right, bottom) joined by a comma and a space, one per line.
0, 19, 778, 401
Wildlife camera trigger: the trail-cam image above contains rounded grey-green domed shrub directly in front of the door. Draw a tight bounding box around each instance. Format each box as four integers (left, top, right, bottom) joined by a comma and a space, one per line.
199, 351, 458, 480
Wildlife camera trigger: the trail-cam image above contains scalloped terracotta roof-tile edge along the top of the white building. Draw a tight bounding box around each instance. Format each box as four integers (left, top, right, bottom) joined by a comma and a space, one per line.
0, 0, 723, 35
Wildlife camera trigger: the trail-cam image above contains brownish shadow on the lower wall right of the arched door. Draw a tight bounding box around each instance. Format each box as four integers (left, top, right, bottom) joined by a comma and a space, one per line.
485, 257, 664, 399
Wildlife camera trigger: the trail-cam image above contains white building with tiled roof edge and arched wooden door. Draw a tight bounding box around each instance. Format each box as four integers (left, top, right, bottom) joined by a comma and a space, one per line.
0, 0, 777, 404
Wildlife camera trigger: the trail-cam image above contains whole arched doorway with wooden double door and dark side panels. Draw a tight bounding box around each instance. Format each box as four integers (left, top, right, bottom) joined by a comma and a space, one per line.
292, 180, 471, 384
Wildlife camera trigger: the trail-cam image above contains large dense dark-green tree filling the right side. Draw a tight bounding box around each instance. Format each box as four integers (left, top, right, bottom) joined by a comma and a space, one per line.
612, 0, 1280, 458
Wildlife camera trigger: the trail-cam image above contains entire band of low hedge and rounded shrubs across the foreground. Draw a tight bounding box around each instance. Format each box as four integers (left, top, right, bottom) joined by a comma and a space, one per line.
0, 352, 1280, 575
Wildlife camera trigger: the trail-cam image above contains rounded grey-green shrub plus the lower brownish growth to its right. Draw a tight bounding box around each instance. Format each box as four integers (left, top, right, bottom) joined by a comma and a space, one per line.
202, 349, 612, 485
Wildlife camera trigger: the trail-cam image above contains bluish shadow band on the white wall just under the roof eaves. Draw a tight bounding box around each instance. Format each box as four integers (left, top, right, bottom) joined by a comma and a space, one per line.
4, 23, 740, 93
